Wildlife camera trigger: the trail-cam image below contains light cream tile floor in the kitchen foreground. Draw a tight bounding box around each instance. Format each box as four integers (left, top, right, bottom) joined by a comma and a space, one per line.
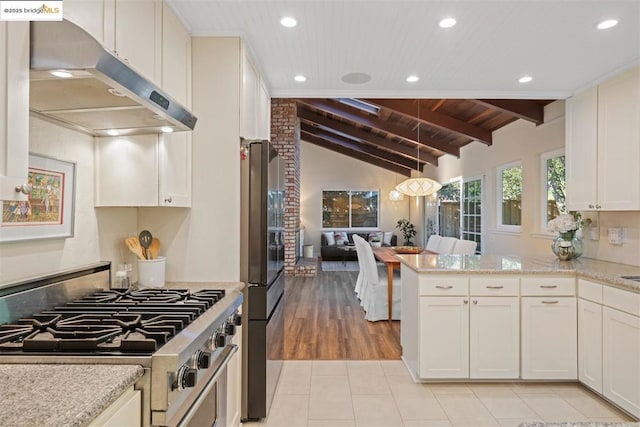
243, 360, 630, 427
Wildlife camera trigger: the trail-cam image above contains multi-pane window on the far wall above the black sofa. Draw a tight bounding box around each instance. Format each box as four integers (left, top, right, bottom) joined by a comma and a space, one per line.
322, 190, 379, 228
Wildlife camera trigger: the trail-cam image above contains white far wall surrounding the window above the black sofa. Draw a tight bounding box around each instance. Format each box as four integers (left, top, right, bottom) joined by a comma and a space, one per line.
300, 141, 410, 255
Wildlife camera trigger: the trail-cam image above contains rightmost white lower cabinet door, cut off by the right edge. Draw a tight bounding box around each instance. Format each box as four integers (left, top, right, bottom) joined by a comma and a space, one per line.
602, 308, 640, 417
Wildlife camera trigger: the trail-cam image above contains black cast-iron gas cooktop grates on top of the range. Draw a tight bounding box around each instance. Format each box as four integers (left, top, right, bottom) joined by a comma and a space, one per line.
0, 289, 225, 355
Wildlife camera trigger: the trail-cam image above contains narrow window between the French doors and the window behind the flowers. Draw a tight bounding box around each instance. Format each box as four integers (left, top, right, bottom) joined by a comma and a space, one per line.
497, 162, 522, 231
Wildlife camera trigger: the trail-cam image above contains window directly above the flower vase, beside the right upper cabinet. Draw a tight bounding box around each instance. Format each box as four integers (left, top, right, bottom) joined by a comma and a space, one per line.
542, 150, 567, 230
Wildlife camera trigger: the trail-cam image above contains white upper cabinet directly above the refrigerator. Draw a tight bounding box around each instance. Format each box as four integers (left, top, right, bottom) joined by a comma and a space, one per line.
240, 43, 271, 139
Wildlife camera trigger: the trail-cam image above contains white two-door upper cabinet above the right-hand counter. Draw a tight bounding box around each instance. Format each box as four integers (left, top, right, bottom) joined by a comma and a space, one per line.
566, 67, 640, 210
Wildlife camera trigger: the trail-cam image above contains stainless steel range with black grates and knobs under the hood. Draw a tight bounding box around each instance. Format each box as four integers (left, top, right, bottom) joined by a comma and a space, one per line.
0, 263, 243, 426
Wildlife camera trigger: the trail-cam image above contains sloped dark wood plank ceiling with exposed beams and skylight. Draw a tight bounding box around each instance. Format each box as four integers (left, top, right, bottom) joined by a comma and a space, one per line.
296, 98, 553, 176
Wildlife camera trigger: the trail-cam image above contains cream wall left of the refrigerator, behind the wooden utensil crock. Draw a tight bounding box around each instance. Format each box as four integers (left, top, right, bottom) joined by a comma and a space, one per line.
138, 37, 240, 281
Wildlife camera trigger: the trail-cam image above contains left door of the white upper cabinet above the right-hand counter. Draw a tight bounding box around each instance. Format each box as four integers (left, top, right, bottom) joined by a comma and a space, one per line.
565, 87, 598, 210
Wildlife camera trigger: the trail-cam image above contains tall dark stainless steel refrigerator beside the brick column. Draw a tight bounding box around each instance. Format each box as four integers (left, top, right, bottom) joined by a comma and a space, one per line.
240, 140, 284, 420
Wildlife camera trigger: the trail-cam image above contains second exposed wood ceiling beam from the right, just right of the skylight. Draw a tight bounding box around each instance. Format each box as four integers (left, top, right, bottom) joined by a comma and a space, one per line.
364, 99, 493, 145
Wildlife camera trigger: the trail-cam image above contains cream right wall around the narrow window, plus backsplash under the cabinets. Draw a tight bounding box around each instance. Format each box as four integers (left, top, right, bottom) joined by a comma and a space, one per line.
425, 101, 640, 265
